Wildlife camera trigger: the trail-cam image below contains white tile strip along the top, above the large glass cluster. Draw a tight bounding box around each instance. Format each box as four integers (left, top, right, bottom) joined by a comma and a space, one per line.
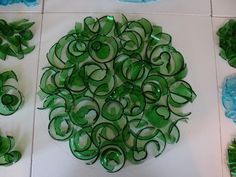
44, 0, 211, 15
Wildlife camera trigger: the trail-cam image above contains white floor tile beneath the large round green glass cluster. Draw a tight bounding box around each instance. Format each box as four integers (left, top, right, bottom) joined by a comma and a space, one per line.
32, 12, 222, 177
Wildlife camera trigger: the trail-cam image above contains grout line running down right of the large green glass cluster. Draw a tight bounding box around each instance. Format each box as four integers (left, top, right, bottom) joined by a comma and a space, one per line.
211, 17, 224, 177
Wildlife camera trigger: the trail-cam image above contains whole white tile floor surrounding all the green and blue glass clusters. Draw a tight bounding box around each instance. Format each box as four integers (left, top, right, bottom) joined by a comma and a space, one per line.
0, 0, 236, 177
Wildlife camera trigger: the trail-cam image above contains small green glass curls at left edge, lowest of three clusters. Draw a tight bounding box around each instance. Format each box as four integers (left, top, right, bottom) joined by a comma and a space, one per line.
0, 136, 21, 166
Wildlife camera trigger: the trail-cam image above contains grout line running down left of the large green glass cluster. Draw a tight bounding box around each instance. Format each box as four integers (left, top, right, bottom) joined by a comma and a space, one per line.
29, 13, 43, 177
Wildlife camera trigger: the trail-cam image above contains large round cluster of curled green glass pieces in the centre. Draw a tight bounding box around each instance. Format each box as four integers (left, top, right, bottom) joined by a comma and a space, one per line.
39, 16, 196, 172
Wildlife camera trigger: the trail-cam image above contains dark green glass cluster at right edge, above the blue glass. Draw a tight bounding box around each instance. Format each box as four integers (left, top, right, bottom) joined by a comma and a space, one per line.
217, 19, 236, 68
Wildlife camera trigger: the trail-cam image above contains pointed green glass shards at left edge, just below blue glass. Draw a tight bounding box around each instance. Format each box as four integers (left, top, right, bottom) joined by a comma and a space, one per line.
0, 19, 35, 60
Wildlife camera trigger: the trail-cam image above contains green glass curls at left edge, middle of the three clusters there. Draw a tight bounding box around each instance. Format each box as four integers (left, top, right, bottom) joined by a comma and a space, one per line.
0, 71, 23, 116
